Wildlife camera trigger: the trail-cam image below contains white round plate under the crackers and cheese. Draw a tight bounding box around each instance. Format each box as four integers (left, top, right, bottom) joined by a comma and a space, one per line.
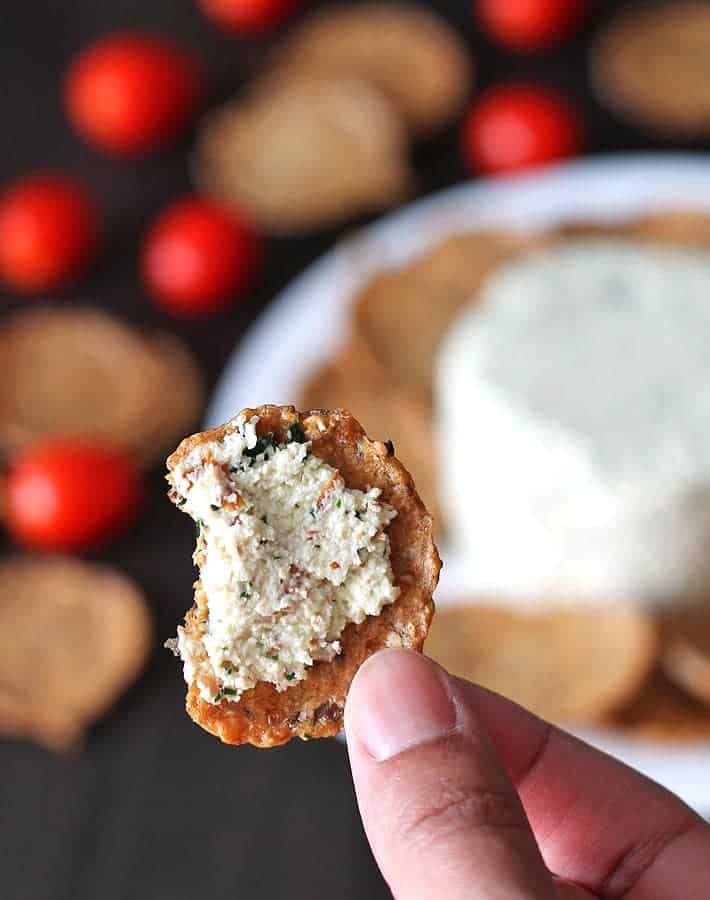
208, 154, 710, 812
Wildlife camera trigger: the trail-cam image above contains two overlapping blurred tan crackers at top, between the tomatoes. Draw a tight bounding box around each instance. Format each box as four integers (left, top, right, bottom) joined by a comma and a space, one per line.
195, 2, 473, 234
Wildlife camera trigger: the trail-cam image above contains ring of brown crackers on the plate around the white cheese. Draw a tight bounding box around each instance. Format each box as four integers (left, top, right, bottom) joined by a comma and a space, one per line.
301, 211, 710, 740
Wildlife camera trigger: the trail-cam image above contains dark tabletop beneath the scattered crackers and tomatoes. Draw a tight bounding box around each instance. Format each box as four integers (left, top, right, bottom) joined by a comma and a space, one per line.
0, 0, 700, 900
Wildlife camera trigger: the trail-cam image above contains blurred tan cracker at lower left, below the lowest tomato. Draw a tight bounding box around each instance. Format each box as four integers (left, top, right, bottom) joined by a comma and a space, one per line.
0, 557, 152, 749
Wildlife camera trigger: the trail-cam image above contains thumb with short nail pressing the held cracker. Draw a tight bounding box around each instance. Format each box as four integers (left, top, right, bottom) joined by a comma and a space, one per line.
345, 650, 558, 900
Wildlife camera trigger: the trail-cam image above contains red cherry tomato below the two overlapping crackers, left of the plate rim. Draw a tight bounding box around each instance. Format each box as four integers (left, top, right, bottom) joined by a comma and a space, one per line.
142, 197, 260, 316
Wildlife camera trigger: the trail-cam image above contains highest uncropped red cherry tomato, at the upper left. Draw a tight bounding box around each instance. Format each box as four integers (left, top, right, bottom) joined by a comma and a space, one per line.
64, 33, 202, 156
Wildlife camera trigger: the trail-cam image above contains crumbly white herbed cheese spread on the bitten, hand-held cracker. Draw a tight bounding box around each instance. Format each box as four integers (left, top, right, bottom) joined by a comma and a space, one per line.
168, 416, 399, 703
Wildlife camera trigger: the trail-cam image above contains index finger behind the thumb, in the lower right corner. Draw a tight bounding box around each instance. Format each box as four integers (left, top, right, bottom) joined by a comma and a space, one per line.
453, 679, 710, 900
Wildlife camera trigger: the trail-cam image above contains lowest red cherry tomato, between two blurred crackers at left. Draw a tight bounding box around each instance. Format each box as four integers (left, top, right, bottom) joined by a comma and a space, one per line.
6, 440, 140, 552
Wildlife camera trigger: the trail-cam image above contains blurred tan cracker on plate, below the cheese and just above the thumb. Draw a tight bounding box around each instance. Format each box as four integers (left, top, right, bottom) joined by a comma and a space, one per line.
426, 606, 657, 724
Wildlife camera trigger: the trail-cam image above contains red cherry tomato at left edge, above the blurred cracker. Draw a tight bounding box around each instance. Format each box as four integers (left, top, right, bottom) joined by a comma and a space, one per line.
0, 175, 99, 294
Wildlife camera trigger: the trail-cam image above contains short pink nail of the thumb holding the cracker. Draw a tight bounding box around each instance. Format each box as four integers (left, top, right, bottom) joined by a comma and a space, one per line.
345, 650, 456, 762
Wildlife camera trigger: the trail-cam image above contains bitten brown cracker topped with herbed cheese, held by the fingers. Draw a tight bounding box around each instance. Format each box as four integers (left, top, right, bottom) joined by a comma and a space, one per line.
168, 406, 441, 747
